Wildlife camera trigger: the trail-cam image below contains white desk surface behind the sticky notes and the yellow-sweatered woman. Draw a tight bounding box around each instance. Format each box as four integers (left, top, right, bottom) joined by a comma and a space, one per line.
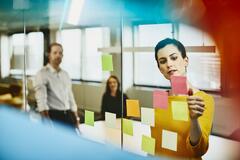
80, 119, 240, 160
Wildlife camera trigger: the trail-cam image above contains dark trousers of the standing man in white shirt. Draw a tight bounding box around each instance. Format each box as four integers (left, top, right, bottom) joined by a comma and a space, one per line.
48, 110, 76, 128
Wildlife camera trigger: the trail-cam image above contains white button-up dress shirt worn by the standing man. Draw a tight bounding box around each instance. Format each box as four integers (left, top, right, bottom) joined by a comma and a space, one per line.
34, 64, 77, 112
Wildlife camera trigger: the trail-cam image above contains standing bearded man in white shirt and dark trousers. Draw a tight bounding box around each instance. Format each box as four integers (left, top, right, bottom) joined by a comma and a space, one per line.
34, 43, 80, 128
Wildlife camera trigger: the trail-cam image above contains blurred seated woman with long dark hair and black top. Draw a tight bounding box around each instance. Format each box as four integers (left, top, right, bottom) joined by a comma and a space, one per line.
101, 75, 128, 119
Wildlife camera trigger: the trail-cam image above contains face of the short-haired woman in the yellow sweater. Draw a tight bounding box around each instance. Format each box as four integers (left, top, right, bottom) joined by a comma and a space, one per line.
157, 44, 188, 80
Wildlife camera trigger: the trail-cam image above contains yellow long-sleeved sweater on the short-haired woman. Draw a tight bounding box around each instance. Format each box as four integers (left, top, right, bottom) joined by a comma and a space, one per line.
151, 91, 214, 159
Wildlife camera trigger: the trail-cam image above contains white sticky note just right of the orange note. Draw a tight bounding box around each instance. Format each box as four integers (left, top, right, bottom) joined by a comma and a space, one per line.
141, 107, 155, 127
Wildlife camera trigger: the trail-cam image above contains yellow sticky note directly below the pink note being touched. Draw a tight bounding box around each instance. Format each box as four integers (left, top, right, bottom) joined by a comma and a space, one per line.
171, 101, 189, 121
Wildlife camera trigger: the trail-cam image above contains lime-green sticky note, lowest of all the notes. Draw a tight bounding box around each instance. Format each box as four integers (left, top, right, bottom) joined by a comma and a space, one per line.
142, 135, 156, 155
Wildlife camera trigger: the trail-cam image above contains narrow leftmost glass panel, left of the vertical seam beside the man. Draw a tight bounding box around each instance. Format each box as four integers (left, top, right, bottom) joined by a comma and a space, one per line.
0, 0, 27, 110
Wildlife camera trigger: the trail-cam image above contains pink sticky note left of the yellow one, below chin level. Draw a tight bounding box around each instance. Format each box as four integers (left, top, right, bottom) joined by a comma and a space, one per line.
153, 90, 168, 109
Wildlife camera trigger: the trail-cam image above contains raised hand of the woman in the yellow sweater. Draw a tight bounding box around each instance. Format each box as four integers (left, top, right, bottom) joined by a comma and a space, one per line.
187, 96, 205, 119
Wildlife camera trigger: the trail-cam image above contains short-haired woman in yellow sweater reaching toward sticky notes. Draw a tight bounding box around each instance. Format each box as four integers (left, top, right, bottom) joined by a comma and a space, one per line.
151, 38, 214, 159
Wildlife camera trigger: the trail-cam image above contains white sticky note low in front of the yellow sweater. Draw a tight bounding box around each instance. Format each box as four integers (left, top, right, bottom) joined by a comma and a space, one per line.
162, 130, 177, 151
